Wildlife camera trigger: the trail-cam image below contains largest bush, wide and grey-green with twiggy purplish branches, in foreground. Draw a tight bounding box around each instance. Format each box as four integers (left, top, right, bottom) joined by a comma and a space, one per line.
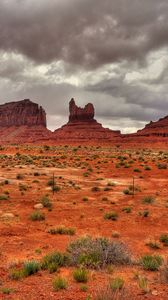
67, 237, 131, 268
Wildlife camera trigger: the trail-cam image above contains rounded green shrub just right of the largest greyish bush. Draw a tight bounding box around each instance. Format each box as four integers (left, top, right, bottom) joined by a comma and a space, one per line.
140, 255, 163, 271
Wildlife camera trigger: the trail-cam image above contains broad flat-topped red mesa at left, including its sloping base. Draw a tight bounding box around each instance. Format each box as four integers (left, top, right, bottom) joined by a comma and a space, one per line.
0, 99, 52, 143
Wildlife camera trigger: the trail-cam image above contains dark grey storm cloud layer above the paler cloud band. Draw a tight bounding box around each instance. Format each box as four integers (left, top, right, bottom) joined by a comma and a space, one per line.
0, 0, 168, 68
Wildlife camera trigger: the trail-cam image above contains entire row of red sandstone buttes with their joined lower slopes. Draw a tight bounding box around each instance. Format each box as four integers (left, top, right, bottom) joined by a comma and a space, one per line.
0, 99, 168, 145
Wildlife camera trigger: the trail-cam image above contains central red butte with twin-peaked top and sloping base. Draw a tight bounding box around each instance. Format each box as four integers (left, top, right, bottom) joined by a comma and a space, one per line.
54, 99, 120, 142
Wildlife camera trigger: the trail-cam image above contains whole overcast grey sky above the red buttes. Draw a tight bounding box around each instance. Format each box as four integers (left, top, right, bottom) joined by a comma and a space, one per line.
0, 0, 168, 132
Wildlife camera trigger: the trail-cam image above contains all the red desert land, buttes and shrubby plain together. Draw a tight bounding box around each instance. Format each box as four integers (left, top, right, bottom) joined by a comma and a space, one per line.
0, 100, 168, 300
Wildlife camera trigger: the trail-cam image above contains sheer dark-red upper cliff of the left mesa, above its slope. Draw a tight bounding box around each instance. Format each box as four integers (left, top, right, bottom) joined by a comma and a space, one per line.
0, 99, 46, 127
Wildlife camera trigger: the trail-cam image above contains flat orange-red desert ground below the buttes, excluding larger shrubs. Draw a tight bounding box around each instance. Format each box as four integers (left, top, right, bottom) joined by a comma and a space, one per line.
0, 145, 168, 300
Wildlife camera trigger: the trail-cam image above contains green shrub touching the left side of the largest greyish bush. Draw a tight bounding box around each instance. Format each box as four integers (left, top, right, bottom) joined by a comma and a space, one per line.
41, 252, 69, 273
